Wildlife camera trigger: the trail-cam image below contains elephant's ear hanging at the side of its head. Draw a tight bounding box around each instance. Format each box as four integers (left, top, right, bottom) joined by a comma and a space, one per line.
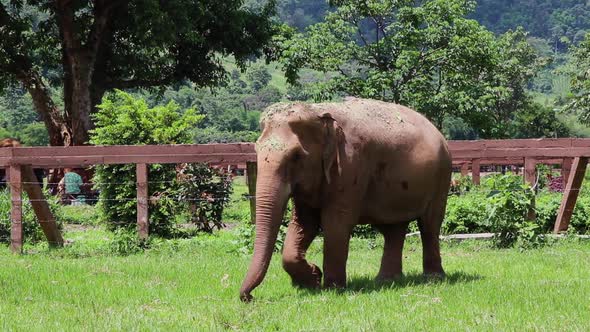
320, 113, 344, 183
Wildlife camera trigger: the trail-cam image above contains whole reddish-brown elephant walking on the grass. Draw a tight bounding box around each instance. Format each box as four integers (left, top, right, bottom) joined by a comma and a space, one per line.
240, 98, 452, 302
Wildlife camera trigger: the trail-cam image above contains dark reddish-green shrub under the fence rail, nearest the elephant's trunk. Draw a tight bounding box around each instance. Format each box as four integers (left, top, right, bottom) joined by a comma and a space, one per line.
178, 164, 232, 233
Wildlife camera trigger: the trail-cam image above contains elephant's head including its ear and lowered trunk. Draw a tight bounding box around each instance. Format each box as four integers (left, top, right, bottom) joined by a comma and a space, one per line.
240, 104, 343, 301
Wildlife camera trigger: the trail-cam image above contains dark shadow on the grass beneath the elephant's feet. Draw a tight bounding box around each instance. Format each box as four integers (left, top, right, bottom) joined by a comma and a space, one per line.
301, 271, 483, 295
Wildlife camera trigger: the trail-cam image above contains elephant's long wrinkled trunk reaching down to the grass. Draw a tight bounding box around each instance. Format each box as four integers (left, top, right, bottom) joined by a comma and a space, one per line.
240, 172, 291, 302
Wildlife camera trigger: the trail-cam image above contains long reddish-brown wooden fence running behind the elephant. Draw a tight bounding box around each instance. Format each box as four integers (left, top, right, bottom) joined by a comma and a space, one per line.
0, 138, 590, 252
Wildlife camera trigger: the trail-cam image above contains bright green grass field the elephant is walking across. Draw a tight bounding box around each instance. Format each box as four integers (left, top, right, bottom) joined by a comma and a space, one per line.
0, 229, 590, 331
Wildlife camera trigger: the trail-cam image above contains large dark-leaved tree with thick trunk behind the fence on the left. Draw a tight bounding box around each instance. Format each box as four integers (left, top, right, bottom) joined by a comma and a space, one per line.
0, 0, 274, 145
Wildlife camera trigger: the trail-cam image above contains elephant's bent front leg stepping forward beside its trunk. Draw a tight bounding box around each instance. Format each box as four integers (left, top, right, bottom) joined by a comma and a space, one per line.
283, 204, 322, 288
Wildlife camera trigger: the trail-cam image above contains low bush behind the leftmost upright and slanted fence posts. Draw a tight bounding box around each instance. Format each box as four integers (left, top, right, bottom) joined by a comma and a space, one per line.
0, 189, 63, 244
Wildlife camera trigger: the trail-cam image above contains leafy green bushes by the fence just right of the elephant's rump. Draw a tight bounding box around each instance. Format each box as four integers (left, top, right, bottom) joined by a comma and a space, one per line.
442, 174, 560, 249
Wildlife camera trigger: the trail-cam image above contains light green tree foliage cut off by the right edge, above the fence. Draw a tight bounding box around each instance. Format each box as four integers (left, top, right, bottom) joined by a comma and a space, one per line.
566, 33, 590, 124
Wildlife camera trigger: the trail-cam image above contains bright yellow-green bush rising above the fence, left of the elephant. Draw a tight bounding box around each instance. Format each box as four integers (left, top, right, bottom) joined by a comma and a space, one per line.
91, 91, 203, 236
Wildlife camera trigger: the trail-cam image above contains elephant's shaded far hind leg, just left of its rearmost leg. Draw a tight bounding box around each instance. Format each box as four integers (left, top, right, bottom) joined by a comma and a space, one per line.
375, 222, 408, 281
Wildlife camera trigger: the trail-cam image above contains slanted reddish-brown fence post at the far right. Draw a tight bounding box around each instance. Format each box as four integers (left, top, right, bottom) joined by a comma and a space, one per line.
553, 157, 588, 233
